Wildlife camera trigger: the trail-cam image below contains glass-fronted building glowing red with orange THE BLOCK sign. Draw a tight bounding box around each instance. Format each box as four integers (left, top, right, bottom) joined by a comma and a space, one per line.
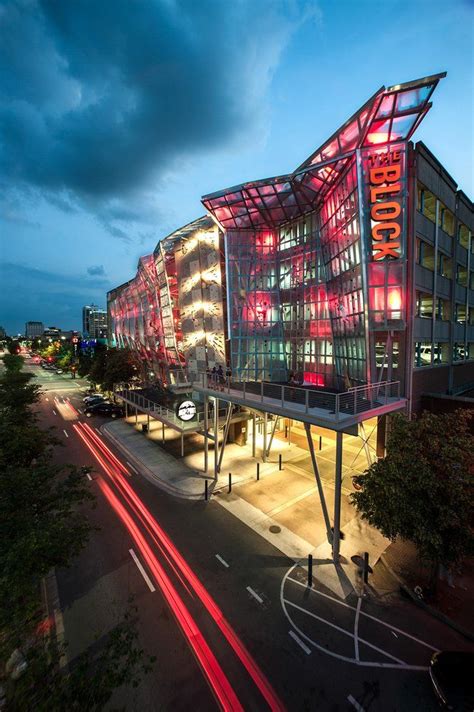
109, 74, 474, 409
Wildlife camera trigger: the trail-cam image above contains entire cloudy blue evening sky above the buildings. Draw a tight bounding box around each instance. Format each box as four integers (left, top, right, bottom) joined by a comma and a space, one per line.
0, 0, 474, 333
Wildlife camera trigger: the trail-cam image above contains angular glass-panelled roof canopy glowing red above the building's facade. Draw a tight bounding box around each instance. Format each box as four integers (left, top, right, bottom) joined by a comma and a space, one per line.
202, 72, 446, 229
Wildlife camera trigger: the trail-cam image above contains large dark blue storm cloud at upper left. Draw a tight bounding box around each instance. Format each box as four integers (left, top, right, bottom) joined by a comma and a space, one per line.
0, 0, 312, 231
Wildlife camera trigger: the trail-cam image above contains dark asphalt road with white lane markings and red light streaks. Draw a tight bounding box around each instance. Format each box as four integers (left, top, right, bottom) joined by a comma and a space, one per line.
29, 365, 467, 712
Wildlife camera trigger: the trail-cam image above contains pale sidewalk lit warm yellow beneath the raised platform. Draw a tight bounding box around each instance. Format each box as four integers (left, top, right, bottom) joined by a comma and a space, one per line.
102, 416, 389, 599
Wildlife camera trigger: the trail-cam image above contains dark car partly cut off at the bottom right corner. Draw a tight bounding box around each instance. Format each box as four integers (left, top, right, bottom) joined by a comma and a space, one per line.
430, 650, 474, 712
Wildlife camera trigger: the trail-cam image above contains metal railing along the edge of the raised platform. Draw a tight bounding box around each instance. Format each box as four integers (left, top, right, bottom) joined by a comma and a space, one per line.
194, 373, 400, 421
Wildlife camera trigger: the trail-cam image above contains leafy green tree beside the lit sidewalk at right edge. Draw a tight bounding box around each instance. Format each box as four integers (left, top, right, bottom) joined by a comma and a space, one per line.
351, 410, 474, 580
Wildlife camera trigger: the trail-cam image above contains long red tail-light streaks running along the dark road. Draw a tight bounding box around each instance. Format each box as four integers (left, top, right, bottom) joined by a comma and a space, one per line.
74, 423, 284, 712
